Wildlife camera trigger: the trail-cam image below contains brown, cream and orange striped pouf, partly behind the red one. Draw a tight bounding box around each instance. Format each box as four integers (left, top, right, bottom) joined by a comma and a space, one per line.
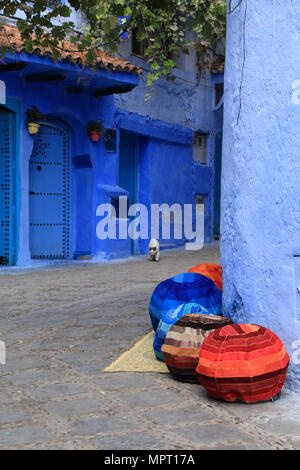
161, 314, 232, 383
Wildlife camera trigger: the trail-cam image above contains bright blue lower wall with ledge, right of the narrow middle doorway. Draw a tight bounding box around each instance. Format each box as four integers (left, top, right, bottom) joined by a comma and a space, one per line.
95, 110, 194, 258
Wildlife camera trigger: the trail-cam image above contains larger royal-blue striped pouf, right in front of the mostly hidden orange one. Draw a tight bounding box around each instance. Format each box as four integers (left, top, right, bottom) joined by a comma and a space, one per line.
149, 273, 222, 331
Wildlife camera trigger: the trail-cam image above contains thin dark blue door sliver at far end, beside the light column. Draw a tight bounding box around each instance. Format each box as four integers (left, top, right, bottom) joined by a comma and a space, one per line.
213, 132, 223, 238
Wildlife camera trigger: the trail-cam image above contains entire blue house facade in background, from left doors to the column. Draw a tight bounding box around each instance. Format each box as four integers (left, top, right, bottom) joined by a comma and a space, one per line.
1, 26, 223, 266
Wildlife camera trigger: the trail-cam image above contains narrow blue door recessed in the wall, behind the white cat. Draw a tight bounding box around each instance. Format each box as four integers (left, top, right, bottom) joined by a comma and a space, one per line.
119, 133, 138, 255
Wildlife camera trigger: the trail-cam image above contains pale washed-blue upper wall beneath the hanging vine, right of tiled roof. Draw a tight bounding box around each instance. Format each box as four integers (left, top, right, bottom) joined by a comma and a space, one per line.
114, 28, 223, 131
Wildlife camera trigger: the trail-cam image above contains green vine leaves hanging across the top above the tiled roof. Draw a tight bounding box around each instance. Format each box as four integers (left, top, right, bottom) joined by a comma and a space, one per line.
0, 0, 226, 87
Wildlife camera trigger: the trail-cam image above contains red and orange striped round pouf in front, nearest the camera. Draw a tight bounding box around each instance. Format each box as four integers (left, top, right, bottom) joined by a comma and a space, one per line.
196, 324, 289, 403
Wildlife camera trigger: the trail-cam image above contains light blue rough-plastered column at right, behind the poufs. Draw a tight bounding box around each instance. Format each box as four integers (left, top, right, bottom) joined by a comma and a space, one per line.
221, 0, 300, 388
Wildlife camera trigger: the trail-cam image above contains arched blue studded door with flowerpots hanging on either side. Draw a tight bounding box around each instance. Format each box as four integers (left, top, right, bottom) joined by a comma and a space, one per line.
29, 120, 70, 259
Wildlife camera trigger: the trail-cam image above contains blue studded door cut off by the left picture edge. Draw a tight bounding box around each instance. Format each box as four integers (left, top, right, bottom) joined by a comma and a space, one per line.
0, 106, 16, 266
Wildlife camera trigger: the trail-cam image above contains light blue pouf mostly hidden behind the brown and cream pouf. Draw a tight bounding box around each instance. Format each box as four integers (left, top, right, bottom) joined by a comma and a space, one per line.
153, 303, 209, 361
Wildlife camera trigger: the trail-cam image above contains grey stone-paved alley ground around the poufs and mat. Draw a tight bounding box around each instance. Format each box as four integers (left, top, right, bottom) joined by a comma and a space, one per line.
0, 246, 300, 450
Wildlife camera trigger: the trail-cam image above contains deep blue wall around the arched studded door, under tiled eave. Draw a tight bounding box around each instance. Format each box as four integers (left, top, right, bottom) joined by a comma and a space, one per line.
1, 55, 132, 266
